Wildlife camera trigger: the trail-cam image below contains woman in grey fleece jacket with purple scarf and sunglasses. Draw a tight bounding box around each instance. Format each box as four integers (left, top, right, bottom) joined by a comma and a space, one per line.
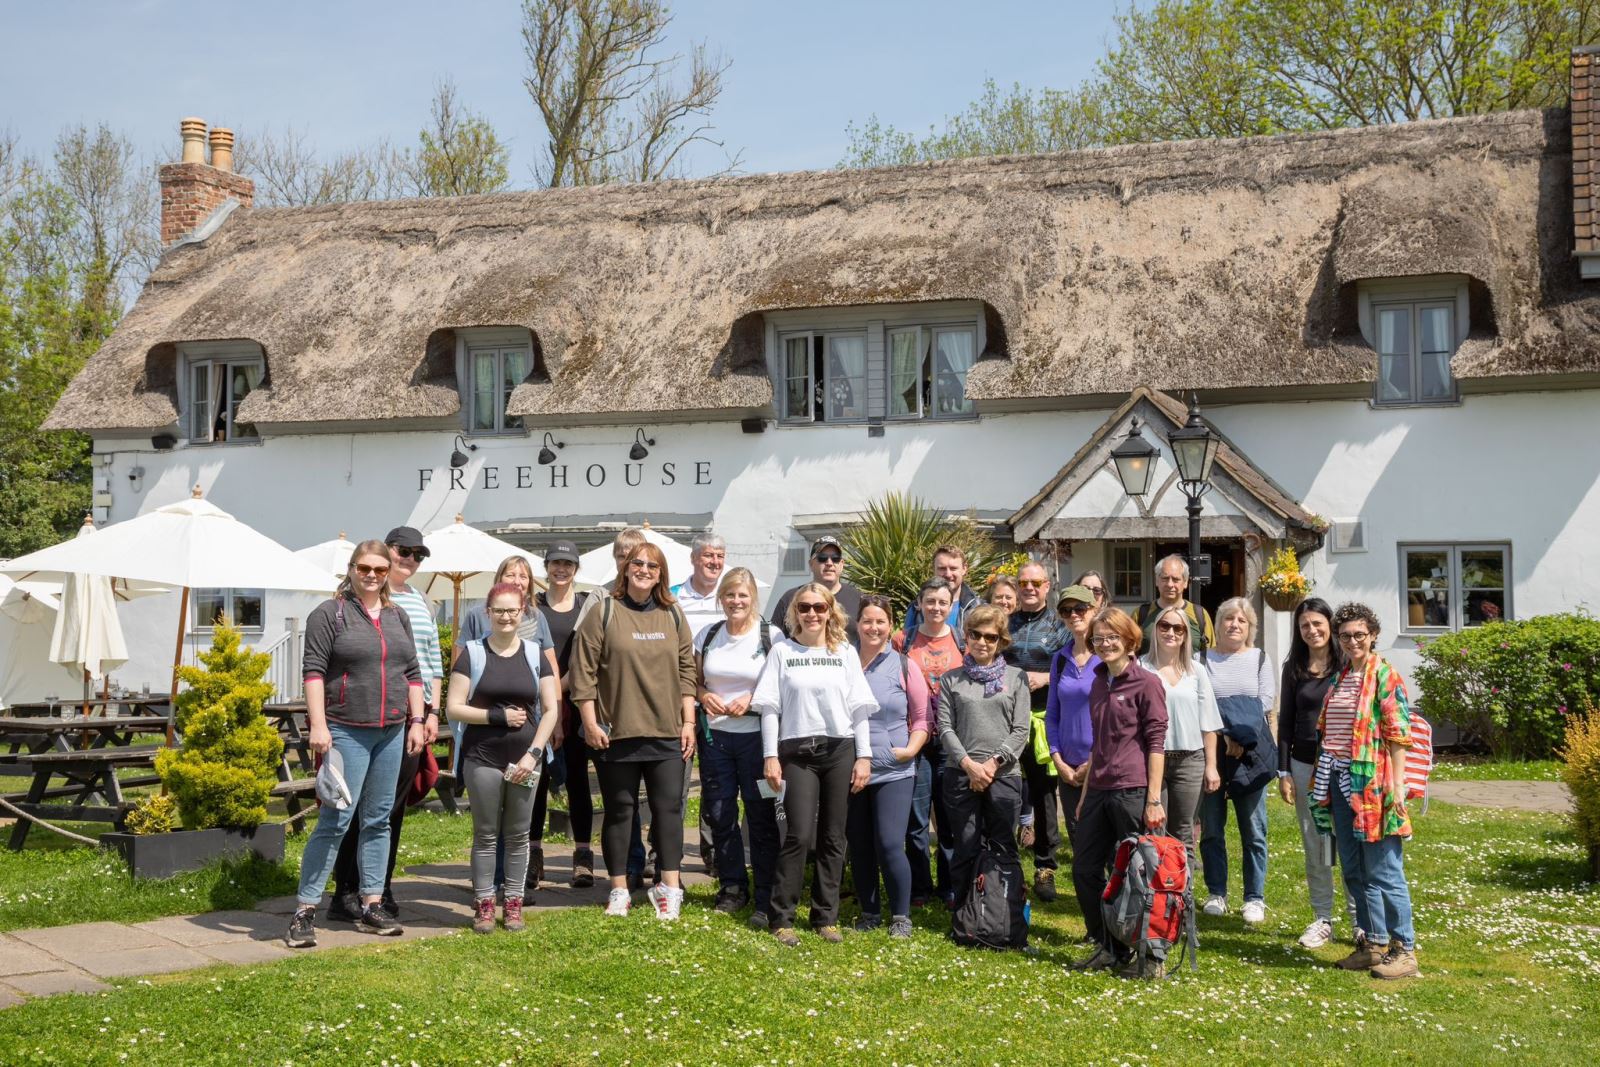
939, 605, 1030, 907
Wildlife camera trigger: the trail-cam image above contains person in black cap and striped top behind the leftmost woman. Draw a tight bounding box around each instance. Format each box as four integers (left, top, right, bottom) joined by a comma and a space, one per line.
328, 526, 445, 923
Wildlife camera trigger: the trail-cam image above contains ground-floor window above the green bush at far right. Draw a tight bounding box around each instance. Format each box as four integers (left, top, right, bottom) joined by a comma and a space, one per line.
1400, 544, 1512, 632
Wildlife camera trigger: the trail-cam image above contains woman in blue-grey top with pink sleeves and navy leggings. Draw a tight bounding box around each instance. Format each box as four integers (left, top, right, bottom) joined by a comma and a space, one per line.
845, 595, 933, 937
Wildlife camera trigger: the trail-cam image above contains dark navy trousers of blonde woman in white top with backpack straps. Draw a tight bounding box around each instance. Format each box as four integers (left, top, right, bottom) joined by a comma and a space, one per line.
701, 729, 779, 913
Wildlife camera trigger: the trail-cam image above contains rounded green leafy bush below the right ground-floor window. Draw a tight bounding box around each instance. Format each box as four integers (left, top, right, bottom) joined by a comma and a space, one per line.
1416, 614, 1600, 760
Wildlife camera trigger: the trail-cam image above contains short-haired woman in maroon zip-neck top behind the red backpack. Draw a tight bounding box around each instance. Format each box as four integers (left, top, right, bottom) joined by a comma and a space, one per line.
1072, 608, 1166, 977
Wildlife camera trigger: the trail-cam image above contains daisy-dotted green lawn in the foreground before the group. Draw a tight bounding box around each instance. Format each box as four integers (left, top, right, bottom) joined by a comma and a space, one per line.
0, 800, 1600, 1065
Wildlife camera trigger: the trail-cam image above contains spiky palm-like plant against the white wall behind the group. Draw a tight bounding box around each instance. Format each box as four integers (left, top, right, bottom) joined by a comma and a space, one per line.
842, 493, 1002, 613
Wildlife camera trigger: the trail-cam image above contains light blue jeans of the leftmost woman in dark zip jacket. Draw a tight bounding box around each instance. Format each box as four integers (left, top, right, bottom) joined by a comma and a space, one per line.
299, 723, 405, 905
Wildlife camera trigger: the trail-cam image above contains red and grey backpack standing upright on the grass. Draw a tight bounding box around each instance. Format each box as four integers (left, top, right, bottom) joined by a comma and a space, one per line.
1101, 829, 1200, 971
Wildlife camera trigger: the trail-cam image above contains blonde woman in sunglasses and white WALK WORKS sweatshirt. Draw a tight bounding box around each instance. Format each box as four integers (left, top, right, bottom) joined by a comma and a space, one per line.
750, 582, 878, 947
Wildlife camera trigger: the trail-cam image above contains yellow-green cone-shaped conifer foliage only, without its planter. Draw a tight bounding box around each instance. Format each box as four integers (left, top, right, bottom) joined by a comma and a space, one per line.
155, 624, 283, 830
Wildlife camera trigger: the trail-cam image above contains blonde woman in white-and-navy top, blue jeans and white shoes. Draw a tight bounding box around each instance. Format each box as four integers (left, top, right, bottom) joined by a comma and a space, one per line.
1200, 597, 1278, 925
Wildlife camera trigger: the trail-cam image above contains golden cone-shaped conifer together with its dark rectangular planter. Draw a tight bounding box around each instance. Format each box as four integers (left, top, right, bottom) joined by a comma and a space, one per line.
101, 622, 283, 878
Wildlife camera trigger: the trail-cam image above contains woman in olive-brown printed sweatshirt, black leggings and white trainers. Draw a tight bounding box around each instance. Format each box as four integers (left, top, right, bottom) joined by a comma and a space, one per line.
571, 542, 699, 920
